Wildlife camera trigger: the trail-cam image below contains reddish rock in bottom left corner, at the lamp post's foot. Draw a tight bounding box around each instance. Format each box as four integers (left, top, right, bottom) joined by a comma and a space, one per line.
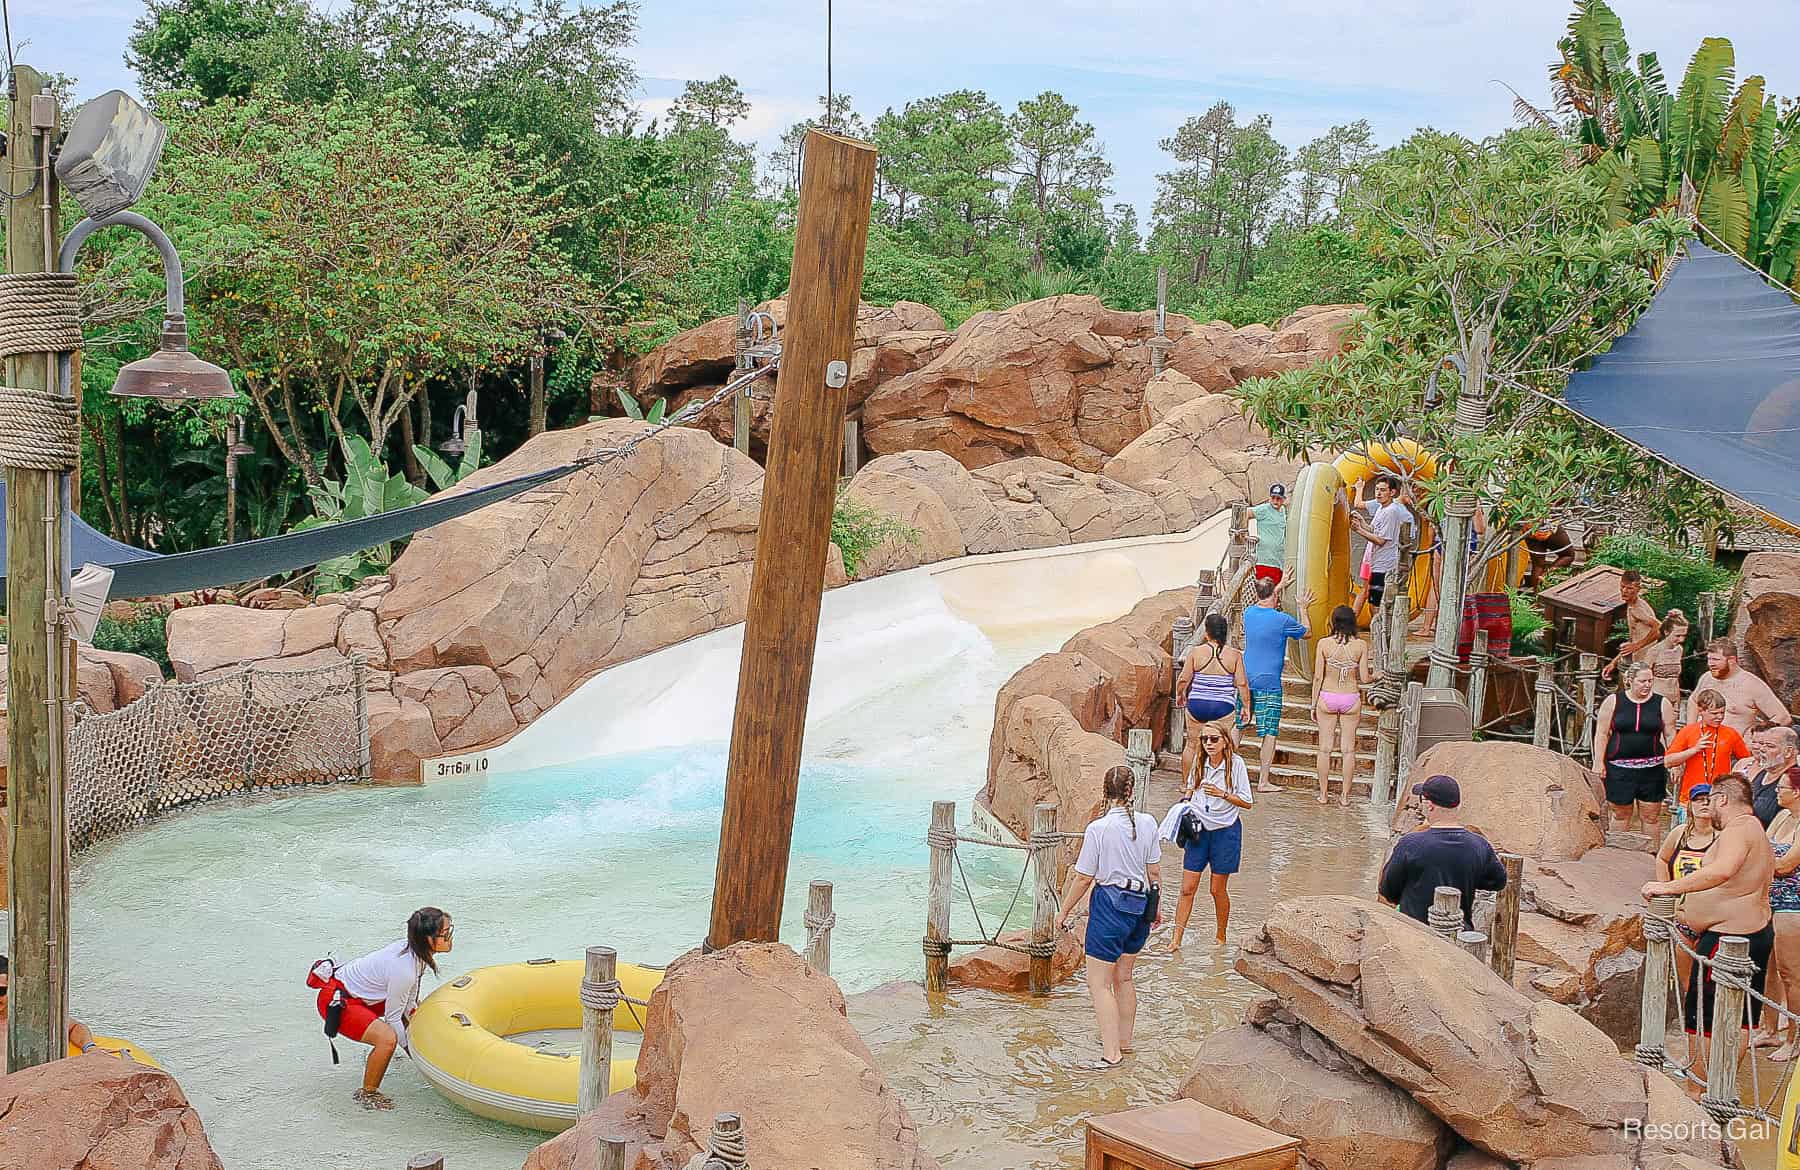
0, 1053, 221, 1170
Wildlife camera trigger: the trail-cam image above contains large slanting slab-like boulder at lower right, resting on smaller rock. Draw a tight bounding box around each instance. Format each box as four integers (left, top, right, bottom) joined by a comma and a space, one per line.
1237, 895, 1735, 1165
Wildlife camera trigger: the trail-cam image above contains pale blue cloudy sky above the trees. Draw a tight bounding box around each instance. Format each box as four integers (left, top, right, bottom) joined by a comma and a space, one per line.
7, 0, 1800, 220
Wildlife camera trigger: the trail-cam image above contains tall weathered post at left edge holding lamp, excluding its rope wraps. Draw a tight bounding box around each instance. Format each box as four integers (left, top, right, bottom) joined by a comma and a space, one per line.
5, 65, 68, 1073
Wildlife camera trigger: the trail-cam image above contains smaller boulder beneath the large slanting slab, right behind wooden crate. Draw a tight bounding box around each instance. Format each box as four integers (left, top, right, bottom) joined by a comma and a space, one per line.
1181, 1012, 1451, 1170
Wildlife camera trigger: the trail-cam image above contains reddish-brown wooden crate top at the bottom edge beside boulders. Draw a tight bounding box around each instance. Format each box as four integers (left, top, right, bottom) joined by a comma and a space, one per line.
1087, 1098, 1300, 1170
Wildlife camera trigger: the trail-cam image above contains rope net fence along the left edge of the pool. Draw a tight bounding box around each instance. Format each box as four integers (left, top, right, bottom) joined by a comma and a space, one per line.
67, 659, 369, 850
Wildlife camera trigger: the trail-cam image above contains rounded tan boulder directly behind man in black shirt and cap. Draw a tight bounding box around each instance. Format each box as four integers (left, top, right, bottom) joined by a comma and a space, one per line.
1393, 742, 1606, 862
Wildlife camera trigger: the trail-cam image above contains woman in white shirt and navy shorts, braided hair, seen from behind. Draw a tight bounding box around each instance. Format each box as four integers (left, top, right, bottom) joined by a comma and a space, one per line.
1062, 765, 1163, 1071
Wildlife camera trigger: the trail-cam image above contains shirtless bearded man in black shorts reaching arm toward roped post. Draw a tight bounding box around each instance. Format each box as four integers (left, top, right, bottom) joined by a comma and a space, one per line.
1643, 772, 1775, 1080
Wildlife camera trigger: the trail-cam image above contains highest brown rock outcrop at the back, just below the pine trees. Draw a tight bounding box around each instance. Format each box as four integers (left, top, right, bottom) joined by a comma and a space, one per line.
862, 297, 1355, 472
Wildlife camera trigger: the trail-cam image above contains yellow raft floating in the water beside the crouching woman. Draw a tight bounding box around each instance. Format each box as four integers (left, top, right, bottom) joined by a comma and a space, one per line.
409, 959, 662, 1130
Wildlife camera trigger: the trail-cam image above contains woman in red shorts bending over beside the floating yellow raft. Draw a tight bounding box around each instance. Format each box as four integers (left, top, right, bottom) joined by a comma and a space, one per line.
306, 905, 455, 1109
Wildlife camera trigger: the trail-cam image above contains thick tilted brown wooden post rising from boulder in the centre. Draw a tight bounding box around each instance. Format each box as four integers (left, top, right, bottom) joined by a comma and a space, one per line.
707, 130, 875, 950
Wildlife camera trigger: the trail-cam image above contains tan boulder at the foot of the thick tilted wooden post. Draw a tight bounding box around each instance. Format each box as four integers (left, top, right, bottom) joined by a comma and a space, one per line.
526, 943, 938, 1170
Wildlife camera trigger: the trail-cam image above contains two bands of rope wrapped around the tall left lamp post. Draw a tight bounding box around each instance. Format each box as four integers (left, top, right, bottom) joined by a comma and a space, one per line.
0, 272, 81, 472
